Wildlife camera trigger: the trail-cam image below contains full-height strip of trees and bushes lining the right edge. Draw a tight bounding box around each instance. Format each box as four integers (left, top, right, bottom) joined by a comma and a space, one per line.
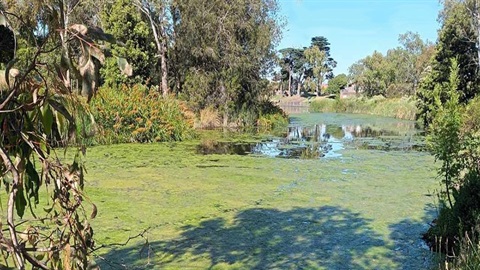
417, 0, 480, 269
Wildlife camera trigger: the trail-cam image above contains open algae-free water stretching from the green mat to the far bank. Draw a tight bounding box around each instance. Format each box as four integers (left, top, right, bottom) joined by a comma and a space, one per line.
197, 113, 425, 159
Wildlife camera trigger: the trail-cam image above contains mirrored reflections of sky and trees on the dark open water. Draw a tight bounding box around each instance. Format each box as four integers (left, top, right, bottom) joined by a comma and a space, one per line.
197, 115, 424, 159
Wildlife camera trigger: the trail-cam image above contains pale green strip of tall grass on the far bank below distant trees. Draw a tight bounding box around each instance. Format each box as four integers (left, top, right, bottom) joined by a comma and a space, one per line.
310, 96, 417, 120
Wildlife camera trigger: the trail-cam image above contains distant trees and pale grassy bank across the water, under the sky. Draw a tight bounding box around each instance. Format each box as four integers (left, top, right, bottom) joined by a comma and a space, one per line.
273, 29, 435, 120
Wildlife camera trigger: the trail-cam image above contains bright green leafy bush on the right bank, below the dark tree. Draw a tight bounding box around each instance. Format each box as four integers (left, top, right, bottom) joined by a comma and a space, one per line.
426, 60, 480, 264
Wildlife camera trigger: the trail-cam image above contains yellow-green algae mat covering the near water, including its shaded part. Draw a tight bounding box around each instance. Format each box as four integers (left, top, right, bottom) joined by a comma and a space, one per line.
86, 142, 437, 269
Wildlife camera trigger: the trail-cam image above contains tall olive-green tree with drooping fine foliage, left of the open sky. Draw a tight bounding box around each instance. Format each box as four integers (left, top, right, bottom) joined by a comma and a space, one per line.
170, 0, 280, 121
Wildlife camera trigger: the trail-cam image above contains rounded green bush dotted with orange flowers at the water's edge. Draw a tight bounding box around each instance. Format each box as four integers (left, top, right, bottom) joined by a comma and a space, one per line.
91, 85, 194, 143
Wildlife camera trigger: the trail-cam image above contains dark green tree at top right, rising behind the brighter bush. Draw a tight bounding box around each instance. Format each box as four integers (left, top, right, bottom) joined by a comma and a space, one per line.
417, 0, 480, 125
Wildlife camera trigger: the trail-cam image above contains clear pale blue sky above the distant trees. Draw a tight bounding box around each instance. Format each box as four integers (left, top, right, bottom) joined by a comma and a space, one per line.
278, 0, 441, 75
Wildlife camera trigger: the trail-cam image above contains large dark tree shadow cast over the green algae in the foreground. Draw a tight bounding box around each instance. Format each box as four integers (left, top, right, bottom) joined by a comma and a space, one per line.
99, 206, 392, 269
